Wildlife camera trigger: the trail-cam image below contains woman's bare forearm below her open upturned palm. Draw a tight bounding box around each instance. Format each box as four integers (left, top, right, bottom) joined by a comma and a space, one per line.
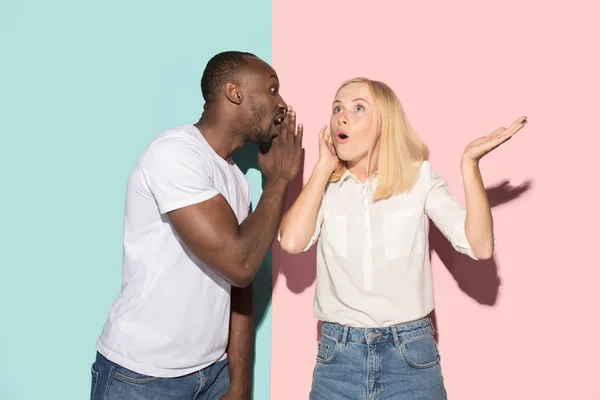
461, 159, 494, 259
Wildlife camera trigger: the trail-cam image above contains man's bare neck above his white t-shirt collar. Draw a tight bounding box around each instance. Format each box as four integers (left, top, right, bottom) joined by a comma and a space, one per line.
194, 112, 245, 160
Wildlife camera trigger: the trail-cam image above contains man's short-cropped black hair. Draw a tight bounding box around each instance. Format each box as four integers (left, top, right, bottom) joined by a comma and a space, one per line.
200, 51, 256, 102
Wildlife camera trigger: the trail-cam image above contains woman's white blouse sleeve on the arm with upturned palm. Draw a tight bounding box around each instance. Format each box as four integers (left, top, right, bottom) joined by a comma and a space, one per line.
425, 161, 496, 260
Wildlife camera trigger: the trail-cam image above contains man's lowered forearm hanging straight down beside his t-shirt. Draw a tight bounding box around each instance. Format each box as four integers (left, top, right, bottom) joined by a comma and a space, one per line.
227, 285, 254, 398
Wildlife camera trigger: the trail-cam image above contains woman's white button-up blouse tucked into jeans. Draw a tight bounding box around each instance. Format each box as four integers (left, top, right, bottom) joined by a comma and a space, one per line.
305, 161, 490, 328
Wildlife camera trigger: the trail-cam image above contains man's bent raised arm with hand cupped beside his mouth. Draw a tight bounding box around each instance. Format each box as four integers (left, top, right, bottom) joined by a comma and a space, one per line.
169, 112, 303, 287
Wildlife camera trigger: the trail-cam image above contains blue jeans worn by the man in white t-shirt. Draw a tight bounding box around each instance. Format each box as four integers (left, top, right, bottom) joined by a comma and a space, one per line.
90, 353, 229, 400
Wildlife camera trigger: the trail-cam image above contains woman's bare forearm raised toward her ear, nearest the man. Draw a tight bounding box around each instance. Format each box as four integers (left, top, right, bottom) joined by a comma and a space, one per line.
280, 160, 331, 254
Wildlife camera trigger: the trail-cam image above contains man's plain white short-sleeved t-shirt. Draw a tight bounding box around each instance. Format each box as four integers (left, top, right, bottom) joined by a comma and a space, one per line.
96, 125, 251, 377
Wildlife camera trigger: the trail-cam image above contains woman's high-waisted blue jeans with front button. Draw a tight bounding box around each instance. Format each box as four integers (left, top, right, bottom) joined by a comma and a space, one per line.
310, 318, 447, 400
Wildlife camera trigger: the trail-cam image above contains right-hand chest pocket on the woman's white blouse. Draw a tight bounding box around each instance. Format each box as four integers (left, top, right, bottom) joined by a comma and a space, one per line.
382, 208, 423, 261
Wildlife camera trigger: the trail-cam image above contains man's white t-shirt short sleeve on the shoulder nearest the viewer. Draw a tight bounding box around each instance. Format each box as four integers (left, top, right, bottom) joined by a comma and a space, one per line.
141, 137, 219, 214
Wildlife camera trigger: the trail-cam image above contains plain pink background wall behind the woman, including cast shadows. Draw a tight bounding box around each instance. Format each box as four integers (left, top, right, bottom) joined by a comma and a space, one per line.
271, 0, 600, 400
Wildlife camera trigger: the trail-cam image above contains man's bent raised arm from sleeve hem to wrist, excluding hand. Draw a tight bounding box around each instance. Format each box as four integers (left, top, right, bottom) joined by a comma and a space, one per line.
168, 177, 288, 287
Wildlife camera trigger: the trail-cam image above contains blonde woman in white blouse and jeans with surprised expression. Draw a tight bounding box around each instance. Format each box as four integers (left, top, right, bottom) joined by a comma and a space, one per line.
280, 78, 527, 400
